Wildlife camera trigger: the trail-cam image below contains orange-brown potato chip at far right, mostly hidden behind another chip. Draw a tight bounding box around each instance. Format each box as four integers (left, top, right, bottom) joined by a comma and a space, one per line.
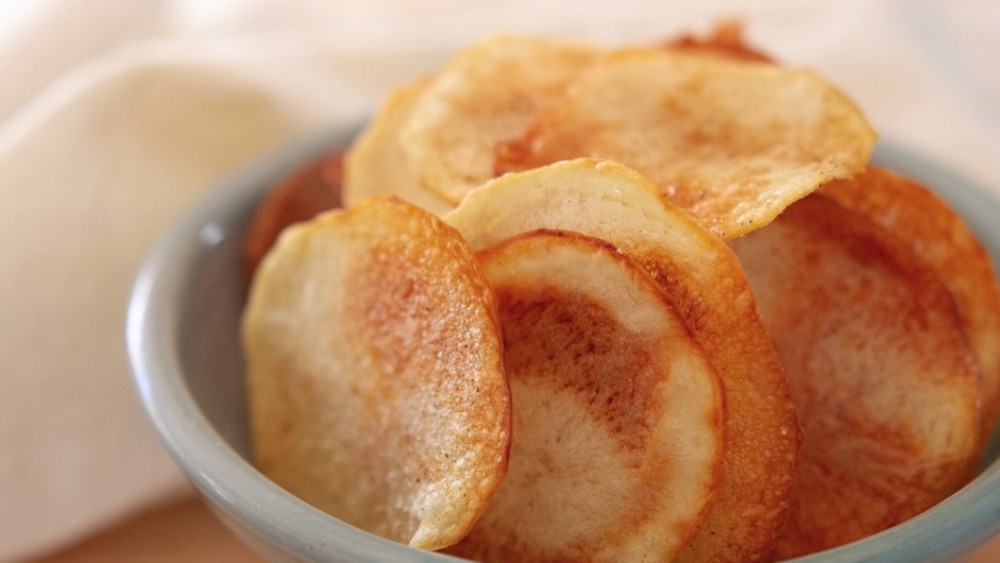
820, 167, 1000, 438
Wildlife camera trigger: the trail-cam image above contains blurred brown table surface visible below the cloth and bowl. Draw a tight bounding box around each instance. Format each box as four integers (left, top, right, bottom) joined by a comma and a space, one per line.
29, 498, 1000, 563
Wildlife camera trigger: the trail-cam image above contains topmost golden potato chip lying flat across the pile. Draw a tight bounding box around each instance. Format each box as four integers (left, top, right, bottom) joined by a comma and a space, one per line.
507, 45, 875, 239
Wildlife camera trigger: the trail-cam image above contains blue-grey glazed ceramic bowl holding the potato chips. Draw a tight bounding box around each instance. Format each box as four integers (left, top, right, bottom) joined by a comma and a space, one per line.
126, 125, 1000, 563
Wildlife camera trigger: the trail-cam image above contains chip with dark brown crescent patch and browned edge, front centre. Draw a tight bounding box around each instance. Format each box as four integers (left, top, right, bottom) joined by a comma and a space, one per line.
453, 231, 725, 561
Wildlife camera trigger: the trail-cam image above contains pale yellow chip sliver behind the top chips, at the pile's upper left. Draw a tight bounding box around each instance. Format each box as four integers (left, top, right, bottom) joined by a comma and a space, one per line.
344, 81, 454, 215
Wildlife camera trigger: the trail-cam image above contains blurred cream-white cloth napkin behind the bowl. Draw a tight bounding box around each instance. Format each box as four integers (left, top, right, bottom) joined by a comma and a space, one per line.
0, 0, 1000, 560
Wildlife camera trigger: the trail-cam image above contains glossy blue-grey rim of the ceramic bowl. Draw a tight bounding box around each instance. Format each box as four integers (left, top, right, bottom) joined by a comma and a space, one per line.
125, 127, 1000, 563
